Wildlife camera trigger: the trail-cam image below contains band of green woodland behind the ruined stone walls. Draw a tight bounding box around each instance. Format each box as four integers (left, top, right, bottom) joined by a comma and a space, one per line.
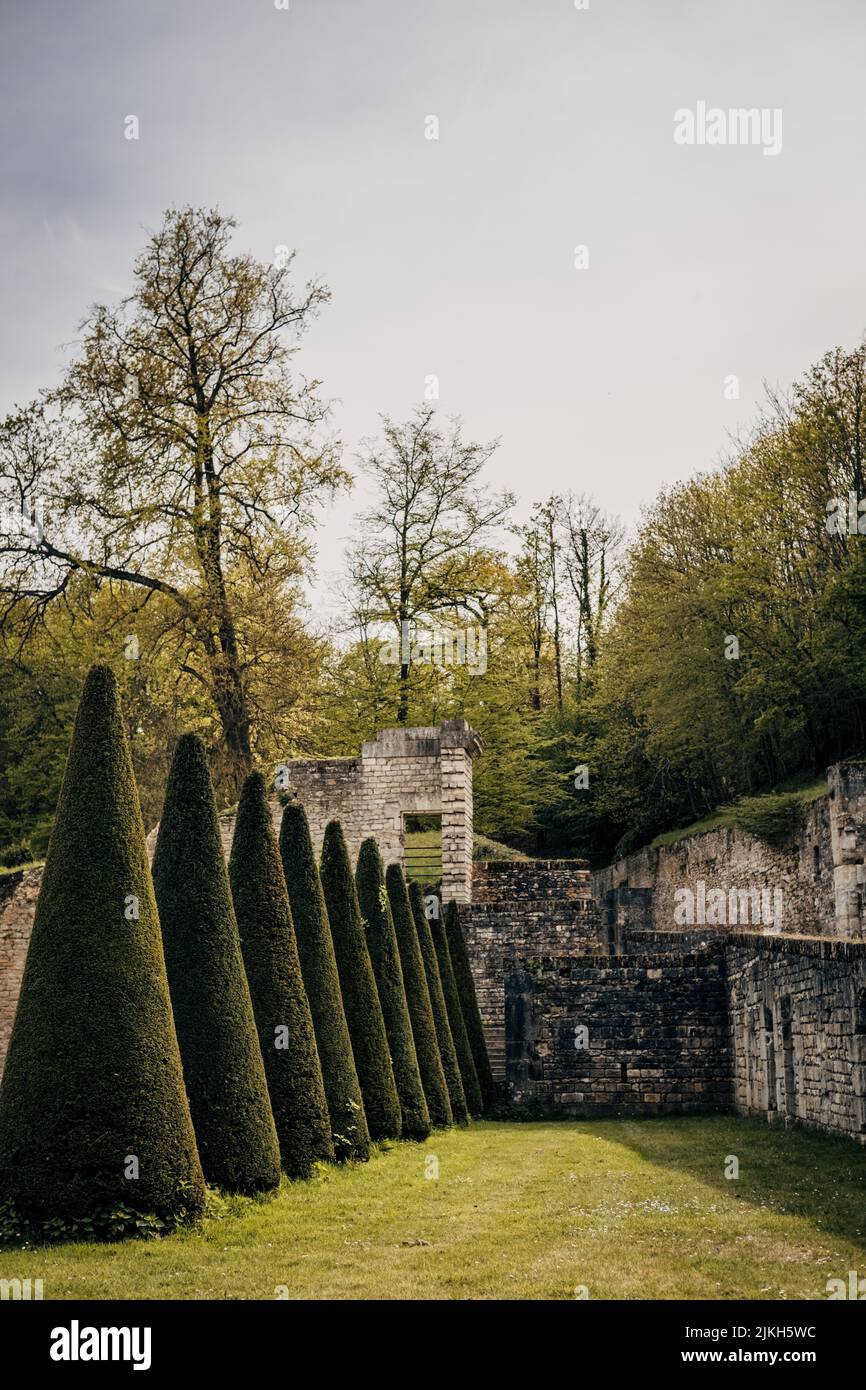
0, 341, 866, 863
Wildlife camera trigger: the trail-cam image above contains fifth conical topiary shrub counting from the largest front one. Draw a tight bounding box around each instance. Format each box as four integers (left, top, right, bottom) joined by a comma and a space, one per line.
321, 820, 402, 1138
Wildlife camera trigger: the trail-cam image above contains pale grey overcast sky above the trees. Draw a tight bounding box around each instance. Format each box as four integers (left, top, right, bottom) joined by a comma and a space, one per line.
0, 0, 866, 612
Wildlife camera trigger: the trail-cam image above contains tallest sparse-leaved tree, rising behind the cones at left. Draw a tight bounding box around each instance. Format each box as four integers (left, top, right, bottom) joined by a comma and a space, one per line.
0, 207, 348, 781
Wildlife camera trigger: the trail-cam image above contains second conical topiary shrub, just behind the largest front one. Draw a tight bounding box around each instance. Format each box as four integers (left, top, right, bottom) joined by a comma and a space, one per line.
153, 734, 279, 1194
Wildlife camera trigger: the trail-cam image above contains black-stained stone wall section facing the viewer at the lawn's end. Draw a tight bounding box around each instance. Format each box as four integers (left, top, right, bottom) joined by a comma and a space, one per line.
506, 942, 731, 1116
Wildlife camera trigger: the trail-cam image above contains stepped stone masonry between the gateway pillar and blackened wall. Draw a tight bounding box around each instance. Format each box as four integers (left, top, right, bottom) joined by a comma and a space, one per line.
460, 859, 606, 1081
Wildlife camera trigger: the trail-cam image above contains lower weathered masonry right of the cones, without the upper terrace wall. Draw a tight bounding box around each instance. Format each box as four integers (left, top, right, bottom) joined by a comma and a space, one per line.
463, 831, 866, 1143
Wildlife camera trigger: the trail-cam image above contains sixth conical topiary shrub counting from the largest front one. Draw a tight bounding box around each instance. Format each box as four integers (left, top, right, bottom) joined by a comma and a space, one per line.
356, 840, 430, 1140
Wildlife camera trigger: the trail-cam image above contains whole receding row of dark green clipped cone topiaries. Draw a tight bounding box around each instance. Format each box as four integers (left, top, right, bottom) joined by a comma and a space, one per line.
0, 667, 492, 1241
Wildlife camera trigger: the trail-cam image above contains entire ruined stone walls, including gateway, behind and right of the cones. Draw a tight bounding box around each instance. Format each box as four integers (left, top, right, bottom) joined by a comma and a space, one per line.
0, 720, 866, 1143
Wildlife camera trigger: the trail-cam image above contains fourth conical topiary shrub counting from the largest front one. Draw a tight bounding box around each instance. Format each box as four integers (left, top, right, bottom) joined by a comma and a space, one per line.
279, 802, 370, 1159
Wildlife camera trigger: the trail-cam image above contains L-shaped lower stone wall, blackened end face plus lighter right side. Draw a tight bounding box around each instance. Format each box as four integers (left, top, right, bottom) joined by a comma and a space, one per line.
503, 931, 866, 1143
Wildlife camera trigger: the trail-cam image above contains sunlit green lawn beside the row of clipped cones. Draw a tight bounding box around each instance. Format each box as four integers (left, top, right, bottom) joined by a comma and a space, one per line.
0, 1116, 866, 1300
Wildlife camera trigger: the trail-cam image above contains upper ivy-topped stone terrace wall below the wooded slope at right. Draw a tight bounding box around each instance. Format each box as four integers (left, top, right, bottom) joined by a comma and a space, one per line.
592, 762, 866, 942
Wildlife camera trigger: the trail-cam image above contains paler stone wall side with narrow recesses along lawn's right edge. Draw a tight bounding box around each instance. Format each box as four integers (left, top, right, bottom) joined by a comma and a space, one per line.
727, 935, 866, 1138
